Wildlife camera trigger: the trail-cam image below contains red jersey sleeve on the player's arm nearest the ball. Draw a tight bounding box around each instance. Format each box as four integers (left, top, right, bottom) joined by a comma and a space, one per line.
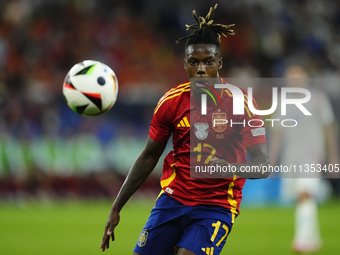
149, 98, 173, 142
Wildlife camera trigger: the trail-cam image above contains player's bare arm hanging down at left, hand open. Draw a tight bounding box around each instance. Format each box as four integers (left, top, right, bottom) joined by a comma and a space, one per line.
100, 137, 167, 251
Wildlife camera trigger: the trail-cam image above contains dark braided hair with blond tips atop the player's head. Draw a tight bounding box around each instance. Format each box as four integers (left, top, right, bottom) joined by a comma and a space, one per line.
176, 4, 235, 49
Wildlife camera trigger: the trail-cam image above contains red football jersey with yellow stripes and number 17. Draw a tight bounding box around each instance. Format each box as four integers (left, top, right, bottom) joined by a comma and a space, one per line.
149, 79, 266, 215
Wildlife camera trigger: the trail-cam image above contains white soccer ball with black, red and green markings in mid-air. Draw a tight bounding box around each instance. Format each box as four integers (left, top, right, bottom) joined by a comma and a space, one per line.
63, 60, 118, 116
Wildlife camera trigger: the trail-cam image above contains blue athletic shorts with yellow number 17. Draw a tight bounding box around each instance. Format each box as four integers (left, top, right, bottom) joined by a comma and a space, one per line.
134, 193, 233, 255
